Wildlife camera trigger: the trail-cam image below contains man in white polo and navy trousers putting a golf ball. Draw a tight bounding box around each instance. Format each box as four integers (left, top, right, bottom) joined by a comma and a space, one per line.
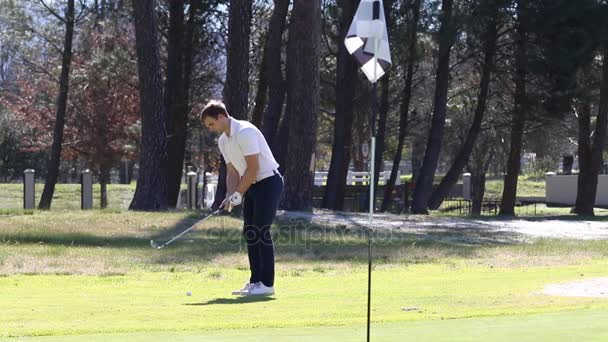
201, 101, 283, 296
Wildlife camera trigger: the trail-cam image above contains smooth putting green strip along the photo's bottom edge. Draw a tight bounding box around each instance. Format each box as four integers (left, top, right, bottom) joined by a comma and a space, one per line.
0, 310, 608, 342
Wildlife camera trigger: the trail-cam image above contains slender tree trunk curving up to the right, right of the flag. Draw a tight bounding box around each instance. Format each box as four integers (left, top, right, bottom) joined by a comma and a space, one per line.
429, 1, 498, 209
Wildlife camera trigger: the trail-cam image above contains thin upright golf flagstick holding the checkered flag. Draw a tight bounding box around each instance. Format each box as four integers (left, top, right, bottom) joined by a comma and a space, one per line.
367, 38, 378, 342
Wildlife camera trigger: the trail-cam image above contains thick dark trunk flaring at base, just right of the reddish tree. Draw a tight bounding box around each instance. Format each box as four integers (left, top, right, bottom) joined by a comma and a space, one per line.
129, 0, 168, 211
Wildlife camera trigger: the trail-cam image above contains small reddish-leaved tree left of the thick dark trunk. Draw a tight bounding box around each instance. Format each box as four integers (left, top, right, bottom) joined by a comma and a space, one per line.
65, 22, 140, 208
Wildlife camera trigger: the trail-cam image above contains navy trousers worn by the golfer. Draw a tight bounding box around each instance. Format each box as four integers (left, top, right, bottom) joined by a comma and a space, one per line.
243, 172, 283, 286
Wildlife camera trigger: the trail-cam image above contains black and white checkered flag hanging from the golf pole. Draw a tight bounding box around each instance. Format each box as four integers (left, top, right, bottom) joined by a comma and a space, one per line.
344, 0, 391, 83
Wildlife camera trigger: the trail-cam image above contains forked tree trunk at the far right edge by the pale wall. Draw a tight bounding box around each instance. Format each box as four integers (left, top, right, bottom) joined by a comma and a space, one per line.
574, 46, 608, 216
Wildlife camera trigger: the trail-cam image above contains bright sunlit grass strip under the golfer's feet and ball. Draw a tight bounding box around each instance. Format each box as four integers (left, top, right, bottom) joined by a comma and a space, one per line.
0, 261, 608, 337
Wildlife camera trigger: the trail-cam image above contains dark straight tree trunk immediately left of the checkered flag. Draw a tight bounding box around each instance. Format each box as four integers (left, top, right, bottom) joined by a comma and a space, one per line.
322, 0, 358, 210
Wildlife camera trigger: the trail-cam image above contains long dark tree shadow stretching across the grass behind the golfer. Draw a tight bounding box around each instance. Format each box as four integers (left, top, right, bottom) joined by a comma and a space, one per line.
0, 213, 532, 265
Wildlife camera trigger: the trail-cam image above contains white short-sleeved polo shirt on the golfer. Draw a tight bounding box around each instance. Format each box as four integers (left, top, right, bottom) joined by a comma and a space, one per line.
218, 118, 279, 181
